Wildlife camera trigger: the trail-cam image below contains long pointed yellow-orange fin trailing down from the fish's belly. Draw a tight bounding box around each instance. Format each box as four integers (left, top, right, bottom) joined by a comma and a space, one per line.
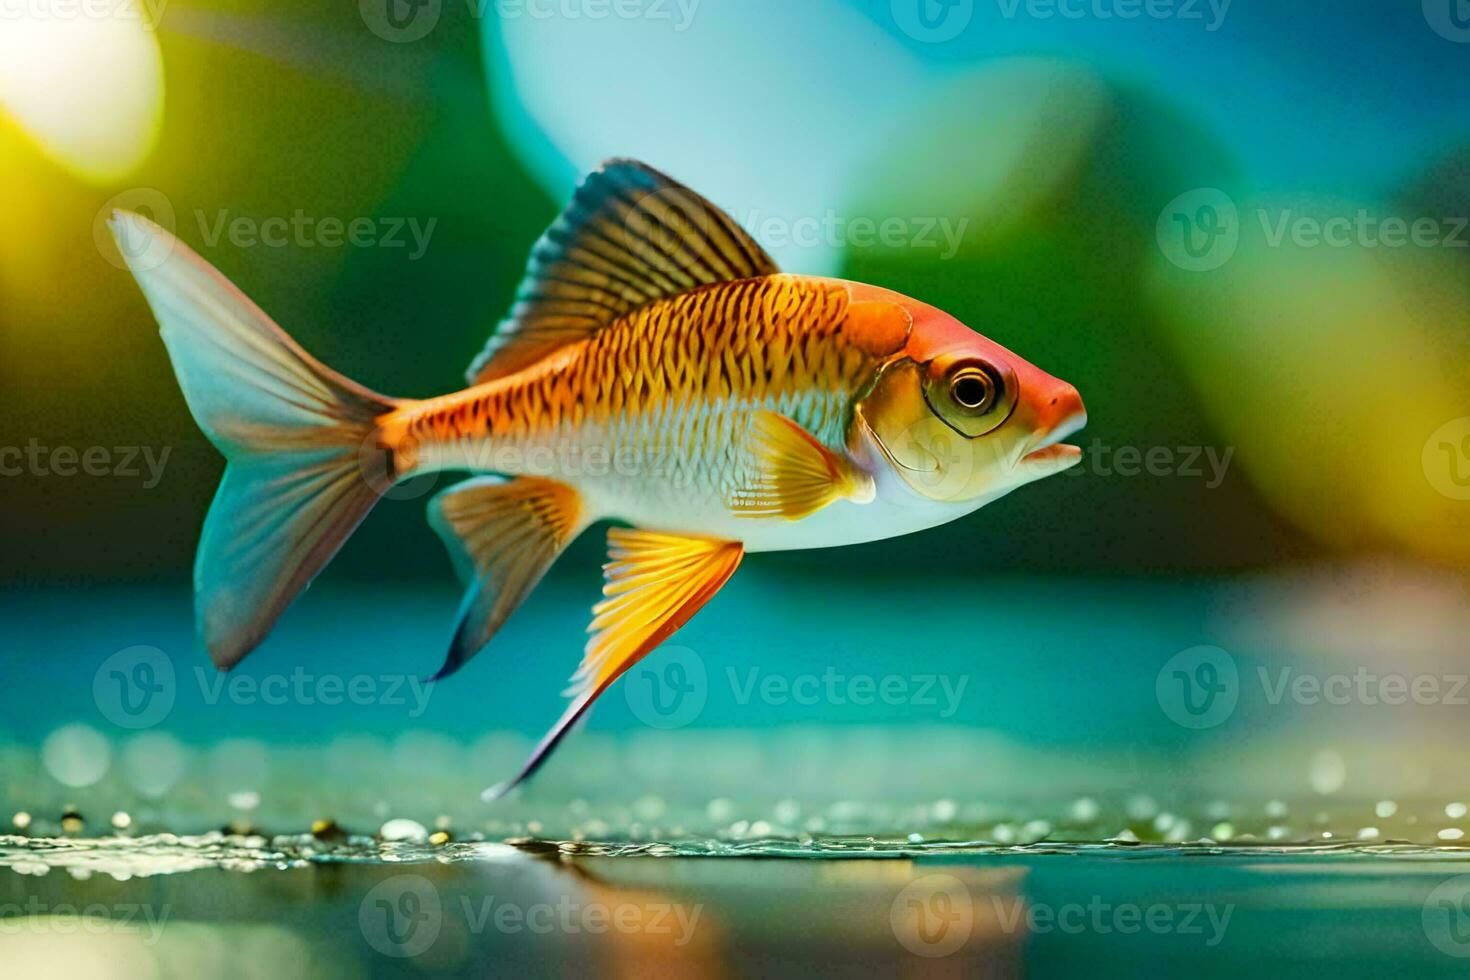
482, 527, 745, 801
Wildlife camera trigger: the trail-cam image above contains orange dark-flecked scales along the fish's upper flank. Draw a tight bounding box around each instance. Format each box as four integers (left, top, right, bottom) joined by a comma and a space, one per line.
394, 275, 873, 491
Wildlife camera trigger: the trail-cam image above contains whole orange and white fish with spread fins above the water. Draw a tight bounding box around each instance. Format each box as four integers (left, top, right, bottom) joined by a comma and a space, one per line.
110, 159, 1086, 799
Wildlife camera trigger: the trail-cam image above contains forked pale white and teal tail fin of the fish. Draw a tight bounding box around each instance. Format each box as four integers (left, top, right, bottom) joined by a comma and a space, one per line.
112, 212, 400, 669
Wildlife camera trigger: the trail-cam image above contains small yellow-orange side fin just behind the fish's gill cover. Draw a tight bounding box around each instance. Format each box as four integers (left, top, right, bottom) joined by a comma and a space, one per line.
731, 411, 873, 520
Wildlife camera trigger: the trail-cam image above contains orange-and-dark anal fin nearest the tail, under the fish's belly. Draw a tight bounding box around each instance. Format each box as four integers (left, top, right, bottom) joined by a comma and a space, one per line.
429, 476, 587, 680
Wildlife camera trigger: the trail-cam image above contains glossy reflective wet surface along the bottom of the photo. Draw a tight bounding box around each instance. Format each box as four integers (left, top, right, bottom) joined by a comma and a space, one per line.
0, 835, 1470, 980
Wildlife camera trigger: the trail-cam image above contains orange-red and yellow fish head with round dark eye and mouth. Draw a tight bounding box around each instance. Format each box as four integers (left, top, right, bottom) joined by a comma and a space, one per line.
854, 291, 1086, 504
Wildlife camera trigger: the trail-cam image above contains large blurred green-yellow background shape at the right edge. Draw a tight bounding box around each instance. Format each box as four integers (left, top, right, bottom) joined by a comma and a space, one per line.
1151, 191, 1470, 563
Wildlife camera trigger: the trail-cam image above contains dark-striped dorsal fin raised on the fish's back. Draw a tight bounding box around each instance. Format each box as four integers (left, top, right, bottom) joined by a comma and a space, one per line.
469, 160, 779, 385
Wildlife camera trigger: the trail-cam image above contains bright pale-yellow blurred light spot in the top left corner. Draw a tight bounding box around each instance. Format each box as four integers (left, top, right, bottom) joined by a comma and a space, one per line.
0, 0, 163, 184
